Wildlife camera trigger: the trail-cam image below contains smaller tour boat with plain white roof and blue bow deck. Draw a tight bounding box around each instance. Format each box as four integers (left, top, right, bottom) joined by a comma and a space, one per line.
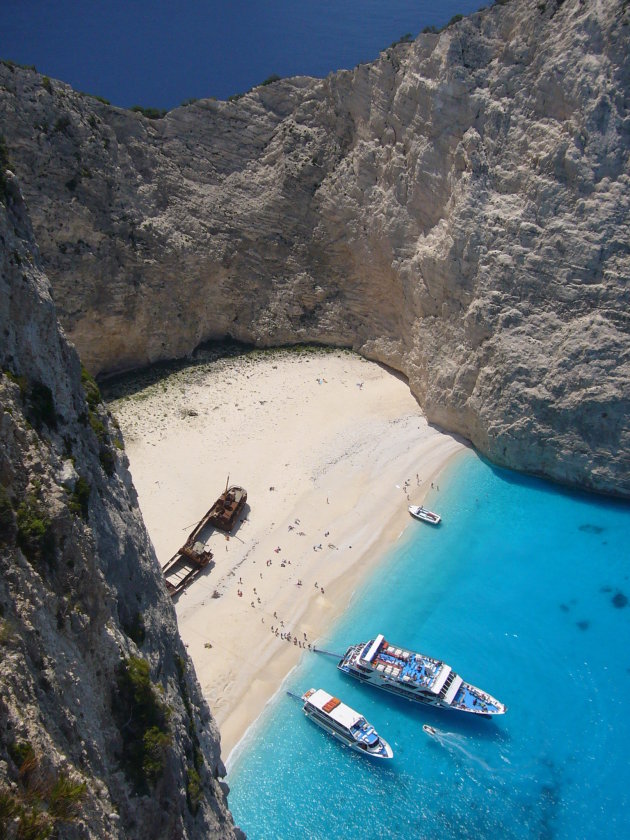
302, 688, 394, 758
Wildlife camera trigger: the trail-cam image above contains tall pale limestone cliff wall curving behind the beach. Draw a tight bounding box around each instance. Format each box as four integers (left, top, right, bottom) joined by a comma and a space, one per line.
0, 0, 630, 495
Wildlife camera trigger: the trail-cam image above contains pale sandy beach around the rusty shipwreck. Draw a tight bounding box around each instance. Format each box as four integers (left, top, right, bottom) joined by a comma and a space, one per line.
111, 351, 463, 756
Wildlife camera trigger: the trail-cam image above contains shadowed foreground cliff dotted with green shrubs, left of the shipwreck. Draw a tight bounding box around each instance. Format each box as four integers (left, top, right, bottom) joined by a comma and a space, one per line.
0, 171, 241, 840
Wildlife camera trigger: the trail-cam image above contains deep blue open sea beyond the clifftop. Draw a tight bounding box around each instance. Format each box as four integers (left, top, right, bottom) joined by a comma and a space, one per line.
0, 0, 492, 109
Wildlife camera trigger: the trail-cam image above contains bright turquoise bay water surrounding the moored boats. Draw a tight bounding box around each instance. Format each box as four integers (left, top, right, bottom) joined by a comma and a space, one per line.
228, 452, 630, 840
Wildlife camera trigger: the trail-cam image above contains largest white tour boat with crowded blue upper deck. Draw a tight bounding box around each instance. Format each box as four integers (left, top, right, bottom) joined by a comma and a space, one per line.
337, 635, 507, 716
